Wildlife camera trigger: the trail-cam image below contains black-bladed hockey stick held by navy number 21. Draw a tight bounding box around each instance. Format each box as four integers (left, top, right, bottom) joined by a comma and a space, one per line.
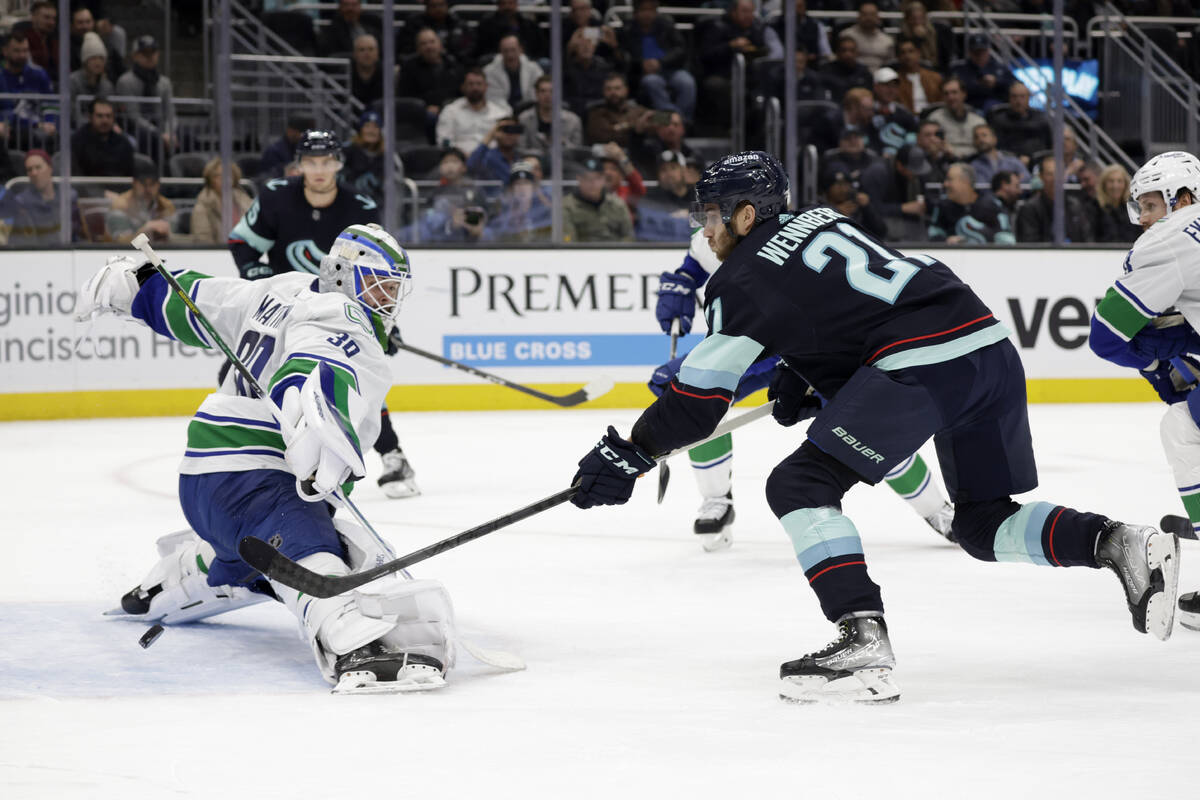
238, 402, 774, 597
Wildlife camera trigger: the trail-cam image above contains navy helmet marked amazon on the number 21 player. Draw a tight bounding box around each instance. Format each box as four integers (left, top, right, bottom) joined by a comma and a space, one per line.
691, 150, 791, 234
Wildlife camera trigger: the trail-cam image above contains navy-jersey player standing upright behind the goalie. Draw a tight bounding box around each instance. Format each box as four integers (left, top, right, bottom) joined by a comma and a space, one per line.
229, 131, 420, 498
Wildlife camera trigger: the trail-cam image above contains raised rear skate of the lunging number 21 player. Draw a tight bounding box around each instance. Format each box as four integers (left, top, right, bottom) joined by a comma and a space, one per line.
1096, 522, 1180, 640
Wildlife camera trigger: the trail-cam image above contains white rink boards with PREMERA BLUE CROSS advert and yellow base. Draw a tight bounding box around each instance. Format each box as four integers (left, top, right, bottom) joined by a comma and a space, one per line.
0, 248, 1154, 420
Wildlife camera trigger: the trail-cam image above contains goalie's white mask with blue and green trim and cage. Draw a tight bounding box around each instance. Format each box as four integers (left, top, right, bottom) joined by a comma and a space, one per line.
317, 222, 413, 330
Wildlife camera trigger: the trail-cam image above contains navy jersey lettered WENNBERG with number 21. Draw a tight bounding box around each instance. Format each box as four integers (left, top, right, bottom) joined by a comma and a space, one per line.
634, 206, 1008, 452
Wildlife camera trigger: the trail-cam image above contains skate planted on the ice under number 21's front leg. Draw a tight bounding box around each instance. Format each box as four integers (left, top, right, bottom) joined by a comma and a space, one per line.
779, 615, 900, 703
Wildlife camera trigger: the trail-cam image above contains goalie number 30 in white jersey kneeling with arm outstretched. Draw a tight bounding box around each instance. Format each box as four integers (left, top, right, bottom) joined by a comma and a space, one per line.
79, 224, 454, 692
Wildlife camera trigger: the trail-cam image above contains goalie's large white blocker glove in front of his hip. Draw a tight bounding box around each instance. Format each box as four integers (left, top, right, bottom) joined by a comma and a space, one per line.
282, 363, 367, 503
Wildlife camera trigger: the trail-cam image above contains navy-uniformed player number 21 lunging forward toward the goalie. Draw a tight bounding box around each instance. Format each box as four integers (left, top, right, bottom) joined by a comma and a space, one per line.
572, 152, 1178, 702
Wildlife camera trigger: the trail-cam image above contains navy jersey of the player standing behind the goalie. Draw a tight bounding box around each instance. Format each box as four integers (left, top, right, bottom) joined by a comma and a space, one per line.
229, 175, 379, 278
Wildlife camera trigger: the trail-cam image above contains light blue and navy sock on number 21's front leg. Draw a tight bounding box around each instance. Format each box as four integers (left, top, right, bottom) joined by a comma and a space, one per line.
780, 506, 883, 622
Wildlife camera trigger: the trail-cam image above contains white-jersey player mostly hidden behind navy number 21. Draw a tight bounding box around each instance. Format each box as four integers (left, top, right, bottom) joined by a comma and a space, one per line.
648, 229, 954, 552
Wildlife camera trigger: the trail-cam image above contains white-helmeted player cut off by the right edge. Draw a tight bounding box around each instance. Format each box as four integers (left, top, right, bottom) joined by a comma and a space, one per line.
1088, 151, 1200, 630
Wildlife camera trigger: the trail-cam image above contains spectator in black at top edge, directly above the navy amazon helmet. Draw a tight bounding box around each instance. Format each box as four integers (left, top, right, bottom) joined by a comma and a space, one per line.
698, 0, 784, 124
